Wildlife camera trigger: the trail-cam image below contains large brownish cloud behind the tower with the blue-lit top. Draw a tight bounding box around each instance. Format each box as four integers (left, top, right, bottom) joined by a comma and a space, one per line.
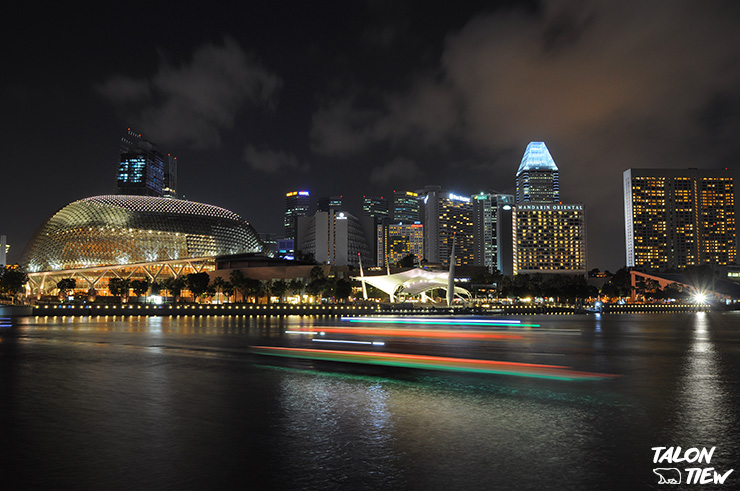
304, 1, 740, 270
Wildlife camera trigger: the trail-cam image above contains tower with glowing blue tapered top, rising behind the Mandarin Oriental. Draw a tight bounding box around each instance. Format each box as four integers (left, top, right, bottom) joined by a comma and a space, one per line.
516, 142, 560, 205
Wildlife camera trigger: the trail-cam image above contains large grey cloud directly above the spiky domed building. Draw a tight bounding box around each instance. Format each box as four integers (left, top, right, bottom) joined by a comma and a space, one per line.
99, 38, 282, 148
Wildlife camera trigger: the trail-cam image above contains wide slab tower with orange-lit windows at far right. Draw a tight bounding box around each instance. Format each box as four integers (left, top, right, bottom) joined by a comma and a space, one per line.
624, 169, 737, 270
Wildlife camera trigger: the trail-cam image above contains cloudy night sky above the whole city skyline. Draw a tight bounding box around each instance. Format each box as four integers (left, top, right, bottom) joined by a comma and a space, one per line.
0, 0, 740, 271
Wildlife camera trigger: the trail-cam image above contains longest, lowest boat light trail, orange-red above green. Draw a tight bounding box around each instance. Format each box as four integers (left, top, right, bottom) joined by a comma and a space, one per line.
250, 346, 616, 381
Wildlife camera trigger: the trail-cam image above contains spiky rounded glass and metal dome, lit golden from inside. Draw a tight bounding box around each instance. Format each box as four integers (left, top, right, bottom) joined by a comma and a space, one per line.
22, 195, 262, 273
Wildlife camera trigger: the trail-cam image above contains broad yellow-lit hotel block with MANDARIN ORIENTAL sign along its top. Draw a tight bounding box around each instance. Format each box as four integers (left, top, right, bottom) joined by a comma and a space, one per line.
513, 203, 586, 275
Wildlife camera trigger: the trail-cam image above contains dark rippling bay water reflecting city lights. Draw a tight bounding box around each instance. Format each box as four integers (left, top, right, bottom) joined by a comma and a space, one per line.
0, 313, 740, 490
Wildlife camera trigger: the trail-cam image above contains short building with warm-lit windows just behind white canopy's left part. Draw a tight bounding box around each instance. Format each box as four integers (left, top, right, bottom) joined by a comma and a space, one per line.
375, 220, 424, 266
